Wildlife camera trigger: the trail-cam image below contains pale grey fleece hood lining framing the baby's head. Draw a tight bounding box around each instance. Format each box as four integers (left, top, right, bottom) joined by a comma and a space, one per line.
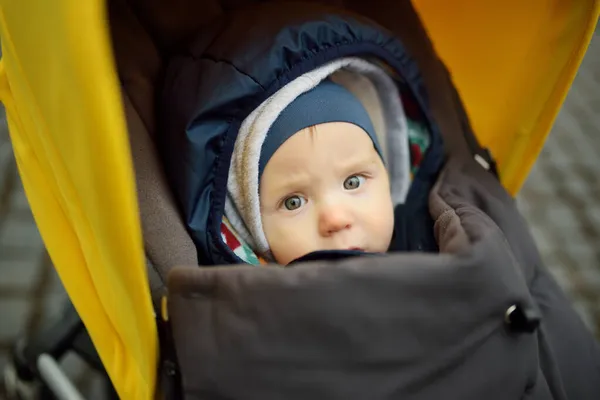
225, 57, 410, 260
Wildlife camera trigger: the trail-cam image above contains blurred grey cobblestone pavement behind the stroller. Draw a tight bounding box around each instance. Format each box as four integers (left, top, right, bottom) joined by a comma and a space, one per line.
0, 31, 600, 399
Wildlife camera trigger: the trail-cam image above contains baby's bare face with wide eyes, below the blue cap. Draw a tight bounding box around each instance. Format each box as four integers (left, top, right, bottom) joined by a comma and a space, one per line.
260, 122, 394, 265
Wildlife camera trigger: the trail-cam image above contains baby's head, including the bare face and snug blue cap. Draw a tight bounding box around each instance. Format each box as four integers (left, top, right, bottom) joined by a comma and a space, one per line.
227, 80, 394, 265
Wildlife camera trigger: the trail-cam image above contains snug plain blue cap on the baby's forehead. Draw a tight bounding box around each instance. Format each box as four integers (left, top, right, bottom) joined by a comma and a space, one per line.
258, 80, 383, 179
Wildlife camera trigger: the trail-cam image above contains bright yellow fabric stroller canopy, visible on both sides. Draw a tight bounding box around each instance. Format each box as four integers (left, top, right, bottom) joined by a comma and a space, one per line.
0, 0, 600, 399
